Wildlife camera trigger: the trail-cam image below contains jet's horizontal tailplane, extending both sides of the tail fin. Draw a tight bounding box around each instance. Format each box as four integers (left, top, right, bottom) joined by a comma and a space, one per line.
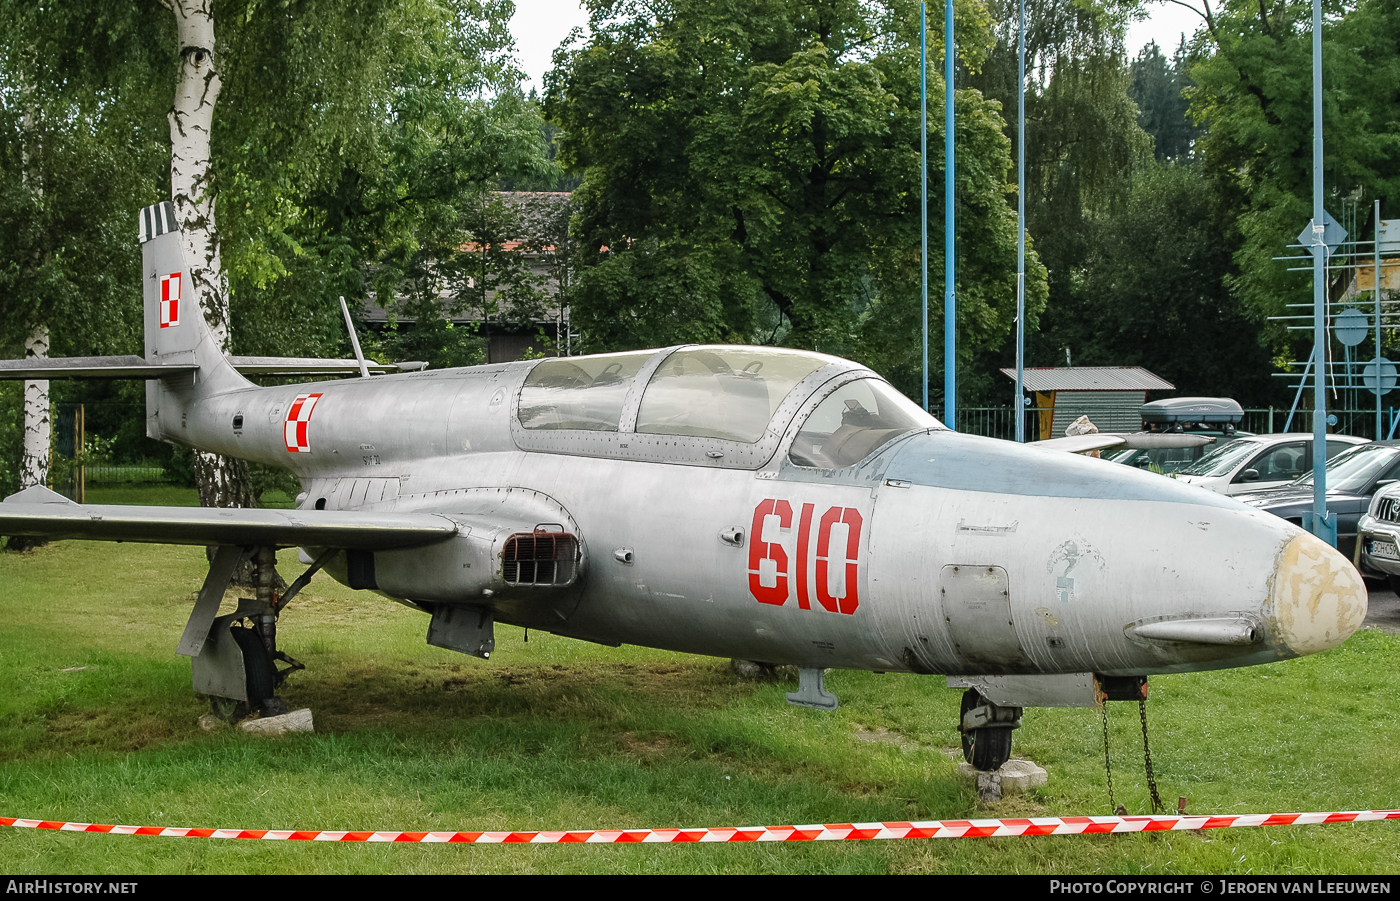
0, 354, 427, 379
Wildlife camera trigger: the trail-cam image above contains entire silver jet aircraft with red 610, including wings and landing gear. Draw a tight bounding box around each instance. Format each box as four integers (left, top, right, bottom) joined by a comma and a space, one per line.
0, 204, 1366, 769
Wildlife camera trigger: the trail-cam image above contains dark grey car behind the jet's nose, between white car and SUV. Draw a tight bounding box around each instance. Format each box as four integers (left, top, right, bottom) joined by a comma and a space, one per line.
1236, 441, 1400, 560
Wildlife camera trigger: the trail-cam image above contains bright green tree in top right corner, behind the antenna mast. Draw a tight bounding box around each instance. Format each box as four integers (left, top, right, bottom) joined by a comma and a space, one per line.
1190, 0, 1400, 332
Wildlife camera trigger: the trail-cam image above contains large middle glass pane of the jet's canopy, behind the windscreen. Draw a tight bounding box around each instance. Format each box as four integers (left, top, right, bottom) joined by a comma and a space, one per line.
637, 347, 832, 444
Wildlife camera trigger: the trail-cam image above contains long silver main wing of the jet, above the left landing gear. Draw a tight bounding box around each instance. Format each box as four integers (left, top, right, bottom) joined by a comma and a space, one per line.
0, 488, 459, 550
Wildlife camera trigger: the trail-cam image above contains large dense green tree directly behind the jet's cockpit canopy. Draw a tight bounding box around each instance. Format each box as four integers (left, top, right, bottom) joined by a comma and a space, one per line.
546, 0, 1039, 405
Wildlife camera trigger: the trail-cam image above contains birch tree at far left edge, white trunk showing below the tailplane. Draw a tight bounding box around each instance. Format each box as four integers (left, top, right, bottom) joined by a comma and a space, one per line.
0, 1, 168, 509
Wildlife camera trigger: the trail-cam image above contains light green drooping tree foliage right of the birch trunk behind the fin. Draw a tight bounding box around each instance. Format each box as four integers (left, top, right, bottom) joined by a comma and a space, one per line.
214, 0, 553, 363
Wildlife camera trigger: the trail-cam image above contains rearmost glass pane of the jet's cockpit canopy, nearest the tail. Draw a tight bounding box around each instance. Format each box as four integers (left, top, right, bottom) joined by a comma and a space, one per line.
519, 351, 652, 432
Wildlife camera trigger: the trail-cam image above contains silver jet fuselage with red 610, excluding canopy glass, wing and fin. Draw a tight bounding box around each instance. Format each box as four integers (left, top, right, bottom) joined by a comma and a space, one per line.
151, 351, 1365, 674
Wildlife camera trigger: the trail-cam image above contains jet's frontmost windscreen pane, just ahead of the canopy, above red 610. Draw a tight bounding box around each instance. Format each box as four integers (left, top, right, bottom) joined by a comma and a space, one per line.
788, 379, 939, 469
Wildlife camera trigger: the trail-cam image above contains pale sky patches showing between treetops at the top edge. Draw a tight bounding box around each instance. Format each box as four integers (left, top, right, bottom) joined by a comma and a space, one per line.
511, 0, 1201, 92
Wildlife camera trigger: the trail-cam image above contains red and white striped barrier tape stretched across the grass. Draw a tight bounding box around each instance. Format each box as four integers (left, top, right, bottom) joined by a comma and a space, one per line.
0, 810, 1400, 845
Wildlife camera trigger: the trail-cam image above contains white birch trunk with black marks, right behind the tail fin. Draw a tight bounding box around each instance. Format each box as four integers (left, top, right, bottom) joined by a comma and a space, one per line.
162, 0, 253, 506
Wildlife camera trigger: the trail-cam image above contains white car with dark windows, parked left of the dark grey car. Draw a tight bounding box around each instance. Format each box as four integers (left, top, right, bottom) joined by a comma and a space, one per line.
1176, 432, 1368, 494
